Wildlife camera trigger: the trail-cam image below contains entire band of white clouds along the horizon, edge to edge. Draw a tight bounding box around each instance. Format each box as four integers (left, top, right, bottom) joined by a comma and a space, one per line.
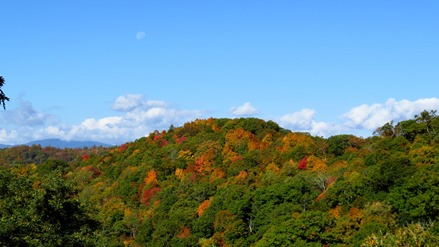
0, 94, 439, 144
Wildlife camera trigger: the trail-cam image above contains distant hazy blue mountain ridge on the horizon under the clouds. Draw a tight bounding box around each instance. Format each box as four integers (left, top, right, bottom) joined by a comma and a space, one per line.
0, 139, 112, 148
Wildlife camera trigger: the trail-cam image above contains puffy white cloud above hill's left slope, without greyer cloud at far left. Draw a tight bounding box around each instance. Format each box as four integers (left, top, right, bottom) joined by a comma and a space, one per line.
60, 95, 202, 144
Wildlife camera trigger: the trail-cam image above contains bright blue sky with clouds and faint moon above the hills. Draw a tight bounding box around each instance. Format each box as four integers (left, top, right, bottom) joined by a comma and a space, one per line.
0, 0, 439, 144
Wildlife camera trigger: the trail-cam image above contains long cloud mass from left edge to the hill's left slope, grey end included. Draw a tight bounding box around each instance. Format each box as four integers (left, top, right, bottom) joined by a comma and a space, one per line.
0, 94, 203, 144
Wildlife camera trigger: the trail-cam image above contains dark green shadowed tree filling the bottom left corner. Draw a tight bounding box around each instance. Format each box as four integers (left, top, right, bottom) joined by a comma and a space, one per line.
0, 167, 98, 246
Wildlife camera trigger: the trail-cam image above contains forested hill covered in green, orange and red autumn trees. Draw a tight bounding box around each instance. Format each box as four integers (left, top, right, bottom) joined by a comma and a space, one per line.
0, 111, 439, 246
